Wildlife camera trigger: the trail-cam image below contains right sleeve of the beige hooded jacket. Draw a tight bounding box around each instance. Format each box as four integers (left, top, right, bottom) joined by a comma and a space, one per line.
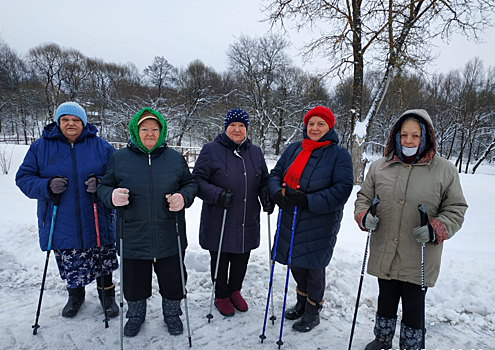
430, 160, 468, 243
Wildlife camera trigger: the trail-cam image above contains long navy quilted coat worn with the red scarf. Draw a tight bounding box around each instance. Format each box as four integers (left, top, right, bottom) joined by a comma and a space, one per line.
268, 129, 353, 269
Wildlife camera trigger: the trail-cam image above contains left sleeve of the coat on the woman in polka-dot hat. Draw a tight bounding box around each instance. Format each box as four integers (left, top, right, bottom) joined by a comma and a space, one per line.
192, 144, 224, 205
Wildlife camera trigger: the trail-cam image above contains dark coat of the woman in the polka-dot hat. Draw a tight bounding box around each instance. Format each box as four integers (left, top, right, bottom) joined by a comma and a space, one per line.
193, 133, 268, 254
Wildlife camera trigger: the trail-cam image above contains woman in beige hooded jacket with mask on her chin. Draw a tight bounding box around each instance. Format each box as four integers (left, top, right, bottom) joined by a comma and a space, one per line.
354, 109, 467, 350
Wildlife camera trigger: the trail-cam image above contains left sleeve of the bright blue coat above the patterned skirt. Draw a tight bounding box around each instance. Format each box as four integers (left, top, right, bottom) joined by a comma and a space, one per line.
15, 144, 50, 201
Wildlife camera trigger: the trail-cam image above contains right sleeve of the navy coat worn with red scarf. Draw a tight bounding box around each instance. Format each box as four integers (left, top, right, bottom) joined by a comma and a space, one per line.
308, 148, 354, 214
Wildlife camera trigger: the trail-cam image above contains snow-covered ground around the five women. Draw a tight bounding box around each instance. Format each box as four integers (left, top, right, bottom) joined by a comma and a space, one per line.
0, 146, 495, 350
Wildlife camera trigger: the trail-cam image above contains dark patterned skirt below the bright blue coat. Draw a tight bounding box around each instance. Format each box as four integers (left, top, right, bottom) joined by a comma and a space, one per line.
53, 244, 119, 288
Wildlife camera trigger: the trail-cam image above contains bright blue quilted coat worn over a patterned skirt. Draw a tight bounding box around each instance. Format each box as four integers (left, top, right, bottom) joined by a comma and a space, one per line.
15, 123, 115, 251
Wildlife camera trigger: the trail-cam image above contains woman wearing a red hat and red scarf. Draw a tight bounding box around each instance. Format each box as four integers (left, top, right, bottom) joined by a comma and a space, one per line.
268, 106, 353, 332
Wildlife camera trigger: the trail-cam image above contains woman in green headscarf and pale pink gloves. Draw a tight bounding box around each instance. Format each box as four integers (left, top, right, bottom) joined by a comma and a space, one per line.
98, 108, 198, 337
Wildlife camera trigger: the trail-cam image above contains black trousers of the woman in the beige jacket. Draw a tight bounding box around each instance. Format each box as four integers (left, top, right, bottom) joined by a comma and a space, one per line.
377, 278, 427, 329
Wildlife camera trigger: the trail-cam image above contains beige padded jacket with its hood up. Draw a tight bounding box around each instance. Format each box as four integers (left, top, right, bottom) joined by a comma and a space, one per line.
354, 110, 468, 287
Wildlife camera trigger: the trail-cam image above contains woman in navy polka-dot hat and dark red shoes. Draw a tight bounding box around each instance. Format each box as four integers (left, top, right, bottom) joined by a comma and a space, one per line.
193, 108, 273, 316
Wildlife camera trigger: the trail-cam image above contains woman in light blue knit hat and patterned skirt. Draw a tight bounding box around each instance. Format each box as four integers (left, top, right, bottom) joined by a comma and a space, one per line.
16, 102, 119, 317
